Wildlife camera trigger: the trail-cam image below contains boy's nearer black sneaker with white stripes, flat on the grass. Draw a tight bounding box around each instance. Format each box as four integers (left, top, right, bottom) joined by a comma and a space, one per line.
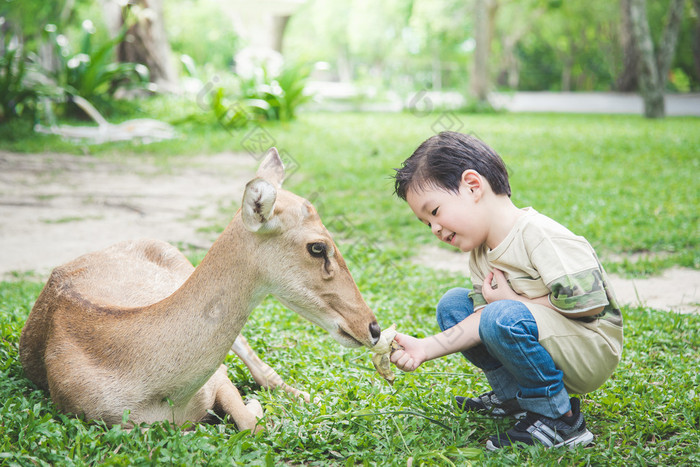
486, 397, 593, 451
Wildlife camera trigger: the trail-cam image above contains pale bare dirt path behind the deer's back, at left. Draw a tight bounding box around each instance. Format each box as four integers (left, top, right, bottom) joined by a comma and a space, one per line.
0, 151, 256, 280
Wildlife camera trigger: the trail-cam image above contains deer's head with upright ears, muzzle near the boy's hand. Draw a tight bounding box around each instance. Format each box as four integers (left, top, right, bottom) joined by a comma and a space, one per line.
241, 148, 381, 347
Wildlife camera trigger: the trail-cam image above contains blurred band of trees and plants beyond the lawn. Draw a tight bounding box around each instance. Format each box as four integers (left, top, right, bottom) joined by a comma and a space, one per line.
0, 0, 700, 127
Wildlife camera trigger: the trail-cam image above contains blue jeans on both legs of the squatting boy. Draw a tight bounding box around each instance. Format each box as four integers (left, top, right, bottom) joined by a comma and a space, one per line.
437, 288, 571, 418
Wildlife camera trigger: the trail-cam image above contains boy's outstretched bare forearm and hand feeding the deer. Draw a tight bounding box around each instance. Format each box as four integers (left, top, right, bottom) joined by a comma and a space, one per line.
391, 310, 481, 371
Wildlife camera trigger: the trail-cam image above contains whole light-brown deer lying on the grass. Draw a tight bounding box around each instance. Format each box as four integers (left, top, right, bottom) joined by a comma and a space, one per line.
19, 148, 381, 430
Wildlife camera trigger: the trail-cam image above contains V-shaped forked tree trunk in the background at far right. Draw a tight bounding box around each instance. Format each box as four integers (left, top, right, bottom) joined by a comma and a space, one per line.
630, 0, 685, 118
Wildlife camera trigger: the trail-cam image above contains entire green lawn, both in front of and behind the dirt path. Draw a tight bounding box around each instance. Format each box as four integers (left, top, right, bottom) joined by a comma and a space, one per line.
0, 104, 700, 465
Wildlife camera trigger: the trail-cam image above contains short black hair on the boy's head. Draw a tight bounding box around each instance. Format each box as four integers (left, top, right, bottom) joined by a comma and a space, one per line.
394, 131, 510, 201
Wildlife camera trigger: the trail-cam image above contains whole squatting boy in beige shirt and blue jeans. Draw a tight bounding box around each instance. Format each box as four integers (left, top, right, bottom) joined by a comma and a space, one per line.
391, 132, 622, 450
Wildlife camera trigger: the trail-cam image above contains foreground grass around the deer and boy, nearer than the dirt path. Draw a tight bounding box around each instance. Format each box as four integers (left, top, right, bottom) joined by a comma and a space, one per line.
0, 267, 700, 465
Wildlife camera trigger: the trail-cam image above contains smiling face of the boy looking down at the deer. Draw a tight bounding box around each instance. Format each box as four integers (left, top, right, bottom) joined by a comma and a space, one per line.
406, 176, 488, 251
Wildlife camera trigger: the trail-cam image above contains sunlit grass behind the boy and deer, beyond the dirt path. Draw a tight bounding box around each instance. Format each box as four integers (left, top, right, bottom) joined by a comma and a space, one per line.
0, 98, 700, 275
